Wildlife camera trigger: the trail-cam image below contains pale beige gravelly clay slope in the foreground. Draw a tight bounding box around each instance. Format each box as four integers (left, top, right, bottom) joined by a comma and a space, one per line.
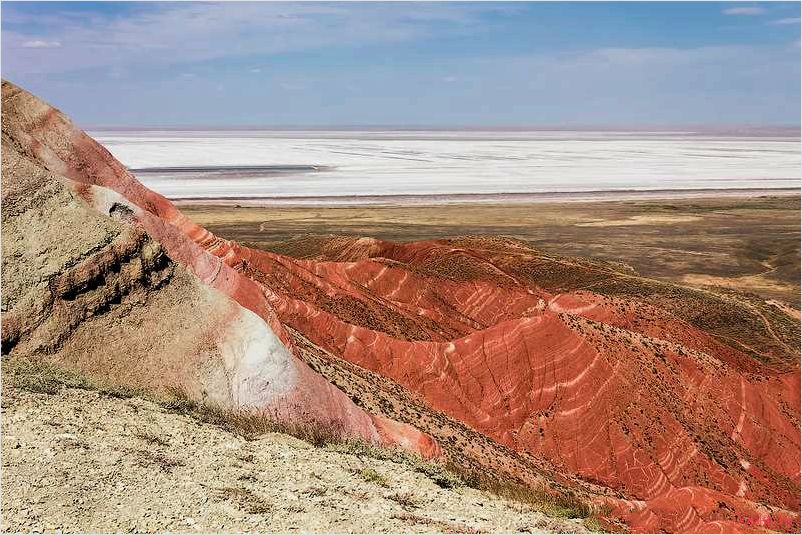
1, 381, 585, 533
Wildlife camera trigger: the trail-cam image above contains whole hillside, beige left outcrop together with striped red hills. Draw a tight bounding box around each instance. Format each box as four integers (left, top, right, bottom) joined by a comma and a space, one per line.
3, 83, 800, 532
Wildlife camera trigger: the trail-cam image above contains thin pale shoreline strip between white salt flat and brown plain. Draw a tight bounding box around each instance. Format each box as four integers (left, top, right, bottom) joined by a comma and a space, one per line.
170, 188, 800, 207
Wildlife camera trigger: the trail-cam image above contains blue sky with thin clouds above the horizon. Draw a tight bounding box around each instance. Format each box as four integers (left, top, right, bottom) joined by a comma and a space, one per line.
2, 2, 800, 127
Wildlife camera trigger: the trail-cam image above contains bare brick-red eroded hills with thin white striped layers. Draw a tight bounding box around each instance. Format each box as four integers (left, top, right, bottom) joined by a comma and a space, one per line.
237, 240, 800, 532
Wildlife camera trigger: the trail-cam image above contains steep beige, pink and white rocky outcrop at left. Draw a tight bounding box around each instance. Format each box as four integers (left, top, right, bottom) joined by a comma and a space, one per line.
3, 82, 437, 455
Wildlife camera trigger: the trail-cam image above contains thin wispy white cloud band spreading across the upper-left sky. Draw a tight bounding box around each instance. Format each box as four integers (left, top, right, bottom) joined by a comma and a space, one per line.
3, 2, 516, 74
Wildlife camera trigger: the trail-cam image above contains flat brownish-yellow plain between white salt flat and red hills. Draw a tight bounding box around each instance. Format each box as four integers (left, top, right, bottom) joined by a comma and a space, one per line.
181, 196, 800, 306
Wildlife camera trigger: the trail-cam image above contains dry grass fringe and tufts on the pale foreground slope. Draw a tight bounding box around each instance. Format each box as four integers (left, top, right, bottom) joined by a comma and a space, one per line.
3, 358, 601, 531
